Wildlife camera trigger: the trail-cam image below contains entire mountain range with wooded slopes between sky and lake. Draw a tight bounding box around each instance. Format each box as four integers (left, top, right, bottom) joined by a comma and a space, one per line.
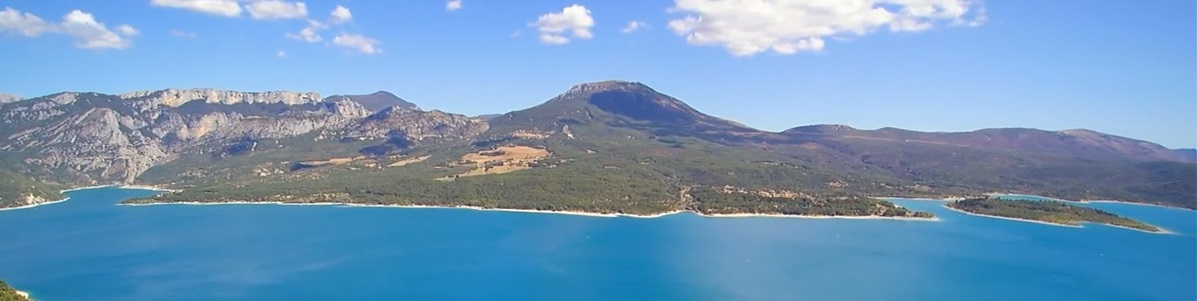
0, 80, 1197, 217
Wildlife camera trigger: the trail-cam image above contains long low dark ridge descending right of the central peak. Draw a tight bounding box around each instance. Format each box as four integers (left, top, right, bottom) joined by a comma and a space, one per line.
783, 125, 1191, 161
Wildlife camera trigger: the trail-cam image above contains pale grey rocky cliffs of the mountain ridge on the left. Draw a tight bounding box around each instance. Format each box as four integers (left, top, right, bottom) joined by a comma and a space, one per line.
0, 89, 487, 185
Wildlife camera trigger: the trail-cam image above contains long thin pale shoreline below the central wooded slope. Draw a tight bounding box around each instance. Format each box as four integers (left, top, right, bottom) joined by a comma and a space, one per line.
116, 201, 941, 222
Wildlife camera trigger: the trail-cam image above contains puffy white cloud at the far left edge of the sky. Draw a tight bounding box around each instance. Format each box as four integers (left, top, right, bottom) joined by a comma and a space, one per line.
0, 7, 139, 49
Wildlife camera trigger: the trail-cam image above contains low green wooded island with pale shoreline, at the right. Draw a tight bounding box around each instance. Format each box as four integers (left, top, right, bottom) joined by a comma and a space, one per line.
946, 198, 1165, 233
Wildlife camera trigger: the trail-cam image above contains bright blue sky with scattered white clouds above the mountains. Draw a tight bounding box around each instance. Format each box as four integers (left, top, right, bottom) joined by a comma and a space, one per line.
0, 0, 1197, 148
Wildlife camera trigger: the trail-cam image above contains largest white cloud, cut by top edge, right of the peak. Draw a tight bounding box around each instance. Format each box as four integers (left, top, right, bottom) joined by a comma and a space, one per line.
669, 0, 984, 56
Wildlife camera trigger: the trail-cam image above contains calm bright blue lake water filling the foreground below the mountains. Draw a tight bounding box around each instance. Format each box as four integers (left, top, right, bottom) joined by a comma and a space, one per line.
0, 188, 1197, 301
